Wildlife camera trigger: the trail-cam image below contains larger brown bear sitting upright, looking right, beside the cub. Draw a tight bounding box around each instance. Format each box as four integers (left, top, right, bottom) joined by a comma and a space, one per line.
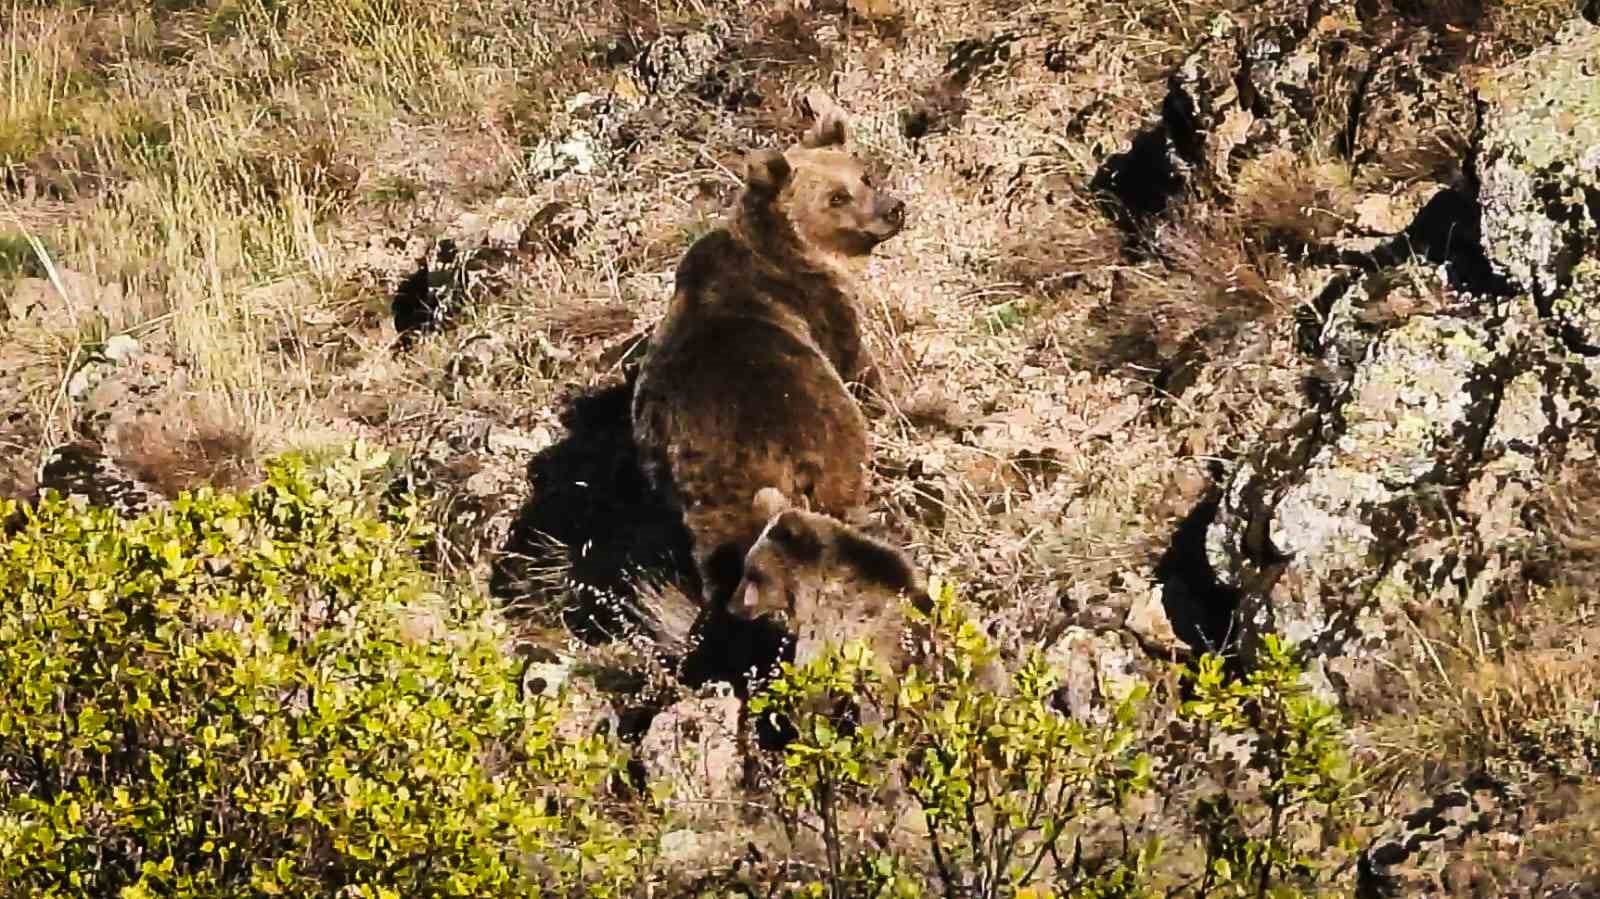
632, 101, 904, 609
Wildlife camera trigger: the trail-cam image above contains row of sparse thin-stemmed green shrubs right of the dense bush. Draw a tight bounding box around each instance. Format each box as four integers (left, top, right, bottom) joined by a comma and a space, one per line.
752, 575, 1362, 899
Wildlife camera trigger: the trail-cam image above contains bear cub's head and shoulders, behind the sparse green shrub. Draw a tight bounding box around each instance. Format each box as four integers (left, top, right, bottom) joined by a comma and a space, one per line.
728, 488, 926, 630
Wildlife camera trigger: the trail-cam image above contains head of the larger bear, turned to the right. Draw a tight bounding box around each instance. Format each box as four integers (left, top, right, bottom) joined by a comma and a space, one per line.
741, 109, 906, 259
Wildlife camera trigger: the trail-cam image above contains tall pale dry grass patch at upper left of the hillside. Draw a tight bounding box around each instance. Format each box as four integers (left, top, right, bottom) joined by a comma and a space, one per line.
0, 0, 576, 457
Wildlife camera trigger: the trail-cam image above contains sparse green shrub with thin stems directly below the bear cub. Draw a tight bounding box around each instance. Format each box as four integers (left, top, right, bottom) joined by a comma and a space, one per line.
752, 584, 1154, 899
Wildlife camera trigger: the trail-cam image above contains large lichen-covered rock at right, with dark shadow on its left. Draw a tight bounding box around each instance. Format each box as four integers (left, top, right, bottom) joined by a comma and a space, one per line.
1206, 291, 1595, 699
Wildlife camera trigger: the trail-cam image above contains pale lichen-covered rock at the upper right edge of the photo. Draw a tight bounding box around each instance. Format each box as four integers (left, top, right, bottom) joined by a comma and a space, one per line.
1477, 21, 1600, 342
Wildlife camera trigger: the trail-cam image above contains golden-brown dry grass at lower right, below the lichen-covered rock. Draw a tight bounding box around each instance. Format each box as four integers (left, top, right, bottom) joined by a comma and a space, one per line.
1368, 459, 1600, 888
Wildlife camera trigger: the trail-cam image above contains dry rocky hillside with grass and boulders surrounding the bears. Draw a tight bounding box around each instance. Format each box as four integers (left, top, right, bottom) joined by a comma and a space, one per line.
0, 0, 1600, 896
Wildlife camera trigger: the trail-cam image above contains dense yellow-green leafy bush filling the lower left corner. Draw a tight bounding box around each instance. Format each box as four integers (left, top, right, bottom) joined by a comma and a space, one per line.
0, 441, 654, 899
